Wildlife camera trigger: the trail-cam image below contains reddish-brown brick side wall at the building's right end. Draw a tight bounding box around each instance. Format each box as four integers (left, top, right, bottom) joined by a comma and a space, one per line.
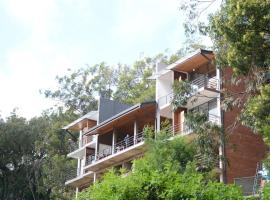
223, 68, 267, 183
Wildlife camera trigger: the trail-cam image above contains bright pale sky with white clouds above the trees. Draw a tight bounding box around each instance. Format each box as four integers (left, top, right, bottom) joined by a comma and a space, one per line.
0, 0, 219, 119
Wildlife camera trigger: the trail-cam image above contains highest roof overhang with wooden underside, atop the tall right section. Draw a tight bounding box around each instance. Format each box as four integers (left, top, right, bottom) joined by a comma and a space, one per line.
167, 49, 214, 73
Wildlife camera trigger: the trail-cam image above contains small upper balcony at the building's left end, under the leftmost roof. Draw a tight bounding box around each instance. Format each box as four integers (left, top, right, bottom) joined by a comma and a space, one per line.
67, 136, 96, 159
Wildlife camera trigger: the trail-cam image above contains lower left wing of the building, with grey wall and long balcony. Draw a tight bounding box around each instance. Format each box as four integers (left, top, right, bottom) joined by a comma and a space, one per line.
64, 98, 156, 193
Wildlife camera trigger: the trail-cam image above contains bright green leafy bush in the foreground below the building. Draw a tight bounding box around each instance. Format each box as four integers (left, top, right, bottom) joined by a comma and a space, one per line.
78, 130, 243, 200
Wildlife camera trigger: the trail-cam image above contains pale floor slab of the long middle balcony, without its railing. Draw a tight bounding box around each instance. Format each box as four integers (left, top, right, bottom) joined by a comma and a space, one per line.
84, 142, 145, 172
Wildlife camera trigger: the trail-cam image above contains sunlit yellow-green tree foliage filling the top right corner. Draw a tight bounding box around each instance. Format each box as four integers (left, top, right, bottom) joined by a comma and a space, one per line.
210, 0, 270, 75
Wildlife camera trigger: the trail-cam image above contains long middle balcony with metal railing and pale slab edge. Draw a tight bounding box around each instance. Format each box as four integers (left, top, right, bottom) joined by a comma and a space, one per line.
84, 132, 145, 171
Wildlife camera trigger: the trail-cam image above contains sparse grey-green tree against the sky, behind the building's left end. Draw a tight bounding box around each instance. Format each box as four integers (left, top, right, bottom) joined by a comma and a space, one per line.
44, 62, 116, 115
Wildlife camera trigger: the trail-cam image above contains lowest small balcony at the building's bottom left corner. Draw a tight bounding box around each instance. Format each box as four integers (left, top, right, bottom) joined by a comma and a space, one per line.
65, 169, 94, 187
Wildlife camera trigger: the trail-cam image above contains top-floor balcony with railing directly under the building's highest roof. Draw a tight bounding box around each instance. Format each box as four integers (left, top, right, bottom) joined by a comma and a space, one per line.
158, 75, 220, 110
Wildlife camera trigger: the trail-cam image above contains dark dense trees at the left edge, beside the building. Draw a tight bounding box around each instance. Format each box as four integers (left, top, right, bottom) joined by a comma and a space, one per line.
0, 113, 76, 200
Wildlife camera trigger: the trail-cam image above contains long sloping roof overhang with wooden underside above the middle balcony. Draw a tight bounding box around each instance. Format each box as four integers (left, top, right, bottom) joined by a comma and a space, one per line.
85, 101, 156, 135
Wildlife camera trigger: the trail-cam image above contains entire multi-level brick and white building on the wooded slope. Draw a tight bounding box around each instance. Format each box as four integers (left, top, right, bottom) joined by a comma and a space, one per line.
64, 49, 267, 195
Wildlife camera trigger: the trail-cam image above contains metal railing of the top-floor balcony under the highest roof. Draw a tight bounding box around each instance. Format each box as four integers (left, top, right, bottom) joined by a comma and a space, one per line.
158, 75, 219, 107
